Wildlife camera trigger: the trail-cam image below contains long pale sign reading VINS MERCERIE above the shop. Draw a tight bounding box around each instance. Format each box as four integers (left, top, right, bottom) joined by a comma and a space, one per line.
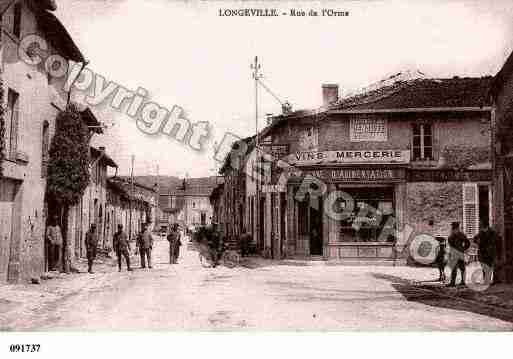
288, 150, 410, 165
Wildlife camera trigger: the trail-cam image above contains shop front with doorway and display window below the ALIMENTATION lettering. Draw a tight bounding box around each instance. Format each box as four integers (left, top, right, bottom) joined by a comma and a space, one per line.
287, 165, 406, 261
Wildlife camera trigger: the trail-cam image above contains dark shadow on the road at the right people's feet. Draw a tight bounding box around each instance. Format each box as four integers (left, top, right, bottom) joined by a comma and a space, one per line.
372, 273, 513, 323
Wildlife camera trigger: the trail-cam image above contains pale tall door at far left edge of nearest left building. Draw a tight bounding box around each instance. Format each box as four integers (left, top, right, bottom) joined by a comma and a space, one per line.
0, 180, 16, 282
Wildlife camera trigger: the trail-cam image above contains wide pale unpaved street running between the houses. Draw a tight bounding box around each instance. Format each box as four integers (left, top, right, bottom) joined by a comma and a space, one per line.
0, 239, 513, 331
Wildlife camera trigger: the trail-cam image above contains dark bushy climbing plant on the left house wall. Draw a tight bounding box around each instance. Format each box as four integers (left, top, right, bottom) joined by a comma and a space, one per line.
46, 104, 90, 209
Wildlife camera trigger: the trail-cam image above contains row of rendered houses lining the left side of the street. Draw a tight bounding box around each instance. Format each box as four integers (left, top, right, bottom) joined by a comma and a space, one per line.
0, 0, 157, 282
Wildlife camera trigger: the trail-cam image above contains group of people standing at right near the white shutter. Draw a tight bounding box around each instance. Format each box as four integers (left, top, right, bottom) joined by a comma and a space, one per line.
436, 221, 498, 287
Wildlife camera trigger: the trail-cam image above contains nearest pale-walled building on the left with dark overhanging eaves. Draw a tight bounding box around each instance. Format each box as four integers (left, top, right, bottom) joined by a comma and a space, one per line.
0, 0, 85, 281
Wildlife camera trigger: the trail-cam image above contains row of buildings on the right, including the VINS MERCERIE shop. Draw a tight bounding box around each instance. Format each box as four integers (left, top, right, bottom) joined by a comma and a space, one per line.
211, 67, 513, 282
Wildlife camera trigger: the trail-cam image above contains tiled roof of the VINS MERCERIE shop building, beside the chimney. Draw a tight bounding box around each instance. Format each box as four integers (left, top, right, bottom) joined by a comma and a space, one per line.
329, 76, 493, 110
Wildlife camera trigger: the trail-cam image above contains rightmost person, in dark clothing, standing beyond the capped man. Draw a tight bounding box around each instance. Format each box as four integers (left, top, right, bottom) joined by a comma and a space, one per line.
474, 219, 498, 284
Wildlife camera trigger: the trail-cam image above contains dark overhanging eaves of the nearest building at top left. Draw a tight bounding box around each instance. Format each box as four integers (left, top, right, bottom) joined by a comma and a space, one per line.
35, 7, 86, 63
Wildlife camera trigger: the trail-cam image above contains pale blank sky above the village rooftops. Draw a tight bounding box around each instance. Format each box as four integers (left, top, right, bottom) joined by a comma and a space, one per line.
56, 0, 513, 177
